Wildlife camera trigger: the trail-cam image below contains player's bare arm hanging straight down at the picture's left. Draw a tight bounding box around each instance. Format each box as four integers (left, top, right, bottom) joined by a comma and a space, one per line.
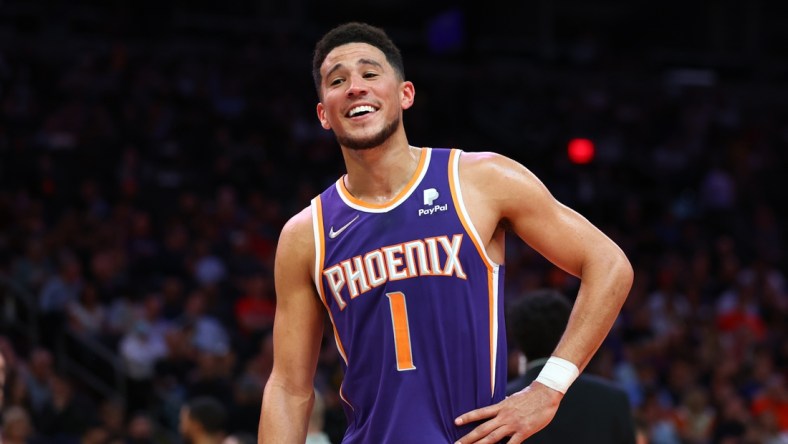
258, 209, 324, 444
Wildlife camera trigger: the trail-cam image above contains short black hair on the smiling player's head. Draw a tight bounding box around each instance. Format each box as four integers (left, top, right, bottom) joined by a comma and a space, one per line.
312, 22, 405, 97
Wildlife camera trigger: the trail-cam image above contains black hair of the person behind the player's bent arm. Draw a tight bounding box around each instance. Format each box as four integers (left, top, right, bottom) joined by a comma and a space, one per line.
506, 289, 572, 360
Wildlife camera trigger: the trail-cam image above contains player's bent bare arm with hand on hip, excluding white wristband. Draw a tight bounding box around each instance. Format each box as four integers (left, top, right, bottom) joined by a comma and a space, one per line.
458, 153, 633, 444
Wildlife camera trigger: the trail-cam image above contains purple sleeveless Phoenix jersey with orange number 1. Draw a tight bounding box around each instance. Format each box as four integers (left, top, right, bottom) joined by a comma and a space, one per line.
312, 148, 507, 444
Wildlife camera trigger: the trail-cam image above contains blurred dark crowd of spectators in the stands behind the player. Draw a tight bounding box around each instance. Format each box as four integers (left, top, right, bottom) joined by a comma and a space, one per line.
0, 3, 788, 444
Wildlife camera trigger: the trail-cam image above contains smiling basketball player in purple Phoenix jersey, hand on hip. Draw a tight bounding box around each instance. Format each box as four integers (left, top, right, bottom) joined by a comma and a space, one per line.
259, 23, 632, 444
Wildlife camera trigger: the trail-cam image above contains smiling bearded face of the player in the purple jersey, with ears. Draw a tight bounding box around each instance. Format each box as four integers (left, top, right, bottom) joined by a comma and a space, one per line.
317, 43, 415, 149
